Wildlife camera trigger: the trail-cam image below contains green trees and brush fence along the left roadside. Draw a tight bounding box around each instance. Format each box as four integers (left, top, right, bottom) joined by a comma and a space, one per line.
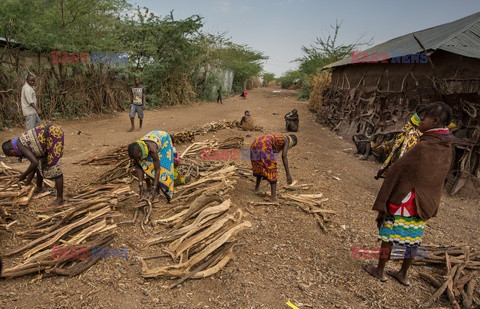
0, 0, 267, 121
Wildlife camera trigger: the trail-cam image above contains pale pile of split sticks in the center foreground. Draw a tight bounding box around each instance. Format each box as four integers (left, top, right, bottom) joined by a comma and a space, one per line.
141, 194, 251, 288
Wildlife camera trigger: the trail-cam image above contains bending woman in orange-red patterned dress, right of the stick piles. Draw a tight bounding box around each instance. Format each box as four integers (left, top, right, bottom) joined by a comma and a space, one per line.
250, 134, 297, 202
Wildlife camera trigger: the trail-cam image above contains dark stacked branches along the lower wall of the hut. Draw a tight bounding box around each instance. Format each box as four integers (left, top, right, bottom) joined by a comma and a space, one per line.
317, 83, 480, 195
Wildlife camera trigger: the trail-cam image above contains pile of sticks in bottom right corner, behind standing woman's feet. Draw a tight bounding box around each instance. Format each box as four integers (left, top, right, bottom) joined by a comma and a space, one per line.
414, 247, 480, 309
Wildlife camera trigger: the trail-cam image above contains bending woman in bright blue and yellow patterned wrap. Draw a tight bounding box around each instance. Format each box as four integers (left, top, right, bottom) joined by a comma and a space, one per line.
128, 130, 174, 202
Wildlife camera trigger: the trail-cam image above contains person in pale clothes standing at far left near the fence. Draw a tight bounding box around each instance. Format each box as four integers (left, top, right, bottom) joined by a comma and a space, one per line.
21, 73, 42, 130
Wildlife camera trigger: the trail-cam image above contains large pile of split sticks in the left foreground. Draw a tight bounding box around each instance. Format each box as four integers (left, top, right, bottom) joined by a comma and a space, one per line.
2, 185, 132, 278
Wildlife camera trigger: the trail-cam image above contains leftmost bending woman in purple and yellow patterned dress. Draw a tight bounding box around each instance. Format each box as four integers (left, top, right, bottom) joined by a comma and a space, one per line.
2, 124, 64, 206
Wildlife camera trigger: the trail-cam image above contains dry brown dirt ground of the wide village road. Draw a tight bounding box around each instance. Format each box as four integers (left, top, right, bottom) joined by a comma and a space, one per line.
0, 88, 480, 308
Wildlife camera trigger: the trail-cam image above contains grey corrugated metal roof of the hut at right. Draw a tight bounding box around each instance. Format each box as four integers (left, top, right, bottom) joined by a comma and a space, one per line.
324, 12, 480, 69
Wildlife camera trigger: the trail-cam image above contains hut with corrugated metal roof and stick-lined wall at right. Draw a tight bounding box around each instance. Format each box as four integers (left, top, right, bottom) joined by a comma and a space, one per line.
317, 12, 480, 193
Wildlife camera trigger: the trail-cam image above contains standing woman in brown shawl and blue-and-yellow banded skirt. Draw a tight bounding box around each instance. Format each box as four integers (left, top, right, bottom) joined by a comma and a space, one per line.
365, 102, 452, 286
